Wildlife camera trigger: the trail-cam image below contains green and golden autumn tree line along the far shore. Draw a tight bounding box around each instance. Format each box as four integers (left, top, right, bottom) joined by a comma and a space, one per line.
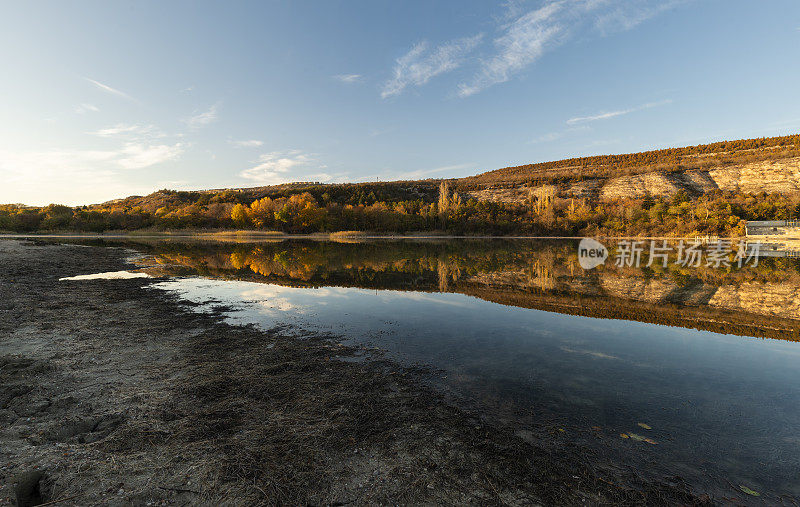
0, 182, 800, 236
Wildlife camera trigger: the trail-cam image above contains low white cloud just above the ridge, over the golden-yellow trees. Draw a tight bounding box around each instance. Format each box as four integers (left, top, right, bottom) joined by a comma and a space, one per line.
239, 150, 331, 185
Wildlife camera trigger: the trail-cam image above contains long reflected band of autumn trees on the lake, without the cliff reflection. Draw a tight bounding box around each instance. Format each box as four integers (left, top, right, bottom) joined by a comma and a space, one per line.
142, 240, 800, 290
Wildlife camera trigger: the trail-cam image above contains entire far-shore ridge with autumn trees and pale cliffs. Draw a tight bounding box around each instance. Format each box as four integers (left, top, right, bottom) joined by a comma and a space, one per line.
0, 135, 800, 236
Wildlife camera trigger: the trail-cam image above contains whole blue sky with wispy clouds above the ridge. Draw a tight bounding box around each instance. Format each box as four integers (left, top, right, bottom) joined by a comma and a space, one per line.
0, 0, 800, 205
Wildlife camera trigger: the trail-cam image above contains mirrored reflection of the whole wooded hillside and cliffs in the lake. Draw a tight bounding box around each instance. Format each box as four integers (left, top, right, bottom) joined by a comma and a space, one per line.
104, 240, 800, 340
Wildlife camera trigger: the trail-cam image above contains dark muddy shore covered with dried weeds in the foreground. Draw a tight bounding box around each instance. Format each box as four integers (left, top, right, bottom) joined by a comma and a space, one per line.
0, 240, 709, 505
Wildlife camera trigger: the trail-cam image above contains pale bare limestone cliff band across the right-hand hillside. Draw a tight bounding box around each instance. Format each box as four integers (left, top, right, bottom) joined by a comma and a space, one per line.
469, 157, 800, 203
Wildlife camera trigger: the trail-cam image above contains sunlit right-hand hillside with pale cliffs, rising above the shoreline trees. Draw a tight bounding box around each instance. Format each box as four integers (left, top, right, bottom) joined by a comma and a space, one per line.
458, 135, 800, 202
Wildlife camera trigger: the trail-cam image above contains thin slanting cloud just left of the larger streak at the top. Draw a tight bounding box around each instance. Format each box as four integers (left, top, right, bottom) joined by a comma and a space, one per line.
381, 34, 483, 99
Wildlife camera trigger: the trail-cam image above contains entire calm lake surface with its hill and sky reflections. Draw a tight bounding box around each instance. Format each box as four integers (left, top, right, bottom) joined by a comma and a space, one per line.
53, 238, 800, 497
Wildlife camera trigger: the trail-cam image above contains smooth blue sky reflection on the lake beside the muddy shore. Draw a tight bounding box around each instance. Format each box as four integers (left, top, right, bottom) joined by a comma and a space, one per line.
155, 278, 800, 495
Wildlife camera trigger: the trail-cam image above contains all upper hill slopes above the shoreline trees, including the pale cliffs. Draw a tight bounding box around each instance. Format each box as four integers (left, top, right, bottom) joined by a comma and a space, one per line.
57, 134, 800, 213
